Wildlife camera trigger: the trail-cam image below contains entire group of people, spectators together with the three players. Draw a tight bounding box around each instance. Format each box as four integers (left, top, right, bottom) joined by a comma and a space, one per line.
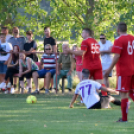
0, 22, 134, 122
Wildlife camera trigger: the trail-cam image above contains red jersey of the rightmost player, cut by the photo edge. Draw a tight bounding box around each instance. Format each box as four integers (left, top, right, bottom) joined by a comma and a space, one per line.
112, 34, 134, 76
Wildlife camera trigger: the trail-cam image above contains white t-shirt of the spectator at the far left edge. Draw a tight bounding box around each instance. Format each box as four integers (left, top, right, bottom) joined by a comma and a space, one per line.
0, 42, 13, 61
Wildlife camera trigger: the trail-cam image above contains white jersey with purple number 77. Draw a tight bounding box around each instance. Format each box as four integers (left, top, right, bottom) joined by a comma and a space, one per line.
75, 79, 101, 108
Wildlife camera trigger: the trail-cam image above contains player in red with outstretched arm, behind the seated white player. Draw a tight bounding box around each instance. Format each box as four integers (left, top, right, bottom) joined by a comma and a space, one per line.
68, 28, 102, 83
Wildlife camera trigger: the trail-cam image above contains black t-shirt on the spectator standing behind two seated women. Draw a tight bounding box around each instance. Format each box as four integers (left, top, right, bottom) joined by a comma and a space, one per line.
24, 40, 37, 60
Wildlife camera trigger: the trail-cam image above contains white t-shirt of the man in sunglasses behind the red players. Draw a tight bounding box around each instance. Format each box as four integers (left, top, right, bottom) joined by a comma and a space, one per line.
99, 40, 113, 70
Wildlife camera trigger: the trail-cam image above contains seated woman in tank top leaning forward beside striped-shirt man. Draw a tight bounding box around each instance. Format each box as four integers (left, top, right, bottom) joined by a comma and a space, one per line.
19, 51, 38, 94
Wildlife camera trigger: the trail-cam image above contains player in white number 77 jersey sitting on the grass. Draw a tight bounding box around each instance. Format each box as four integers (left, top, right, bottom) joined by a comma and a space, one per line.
69, 69, 119, 109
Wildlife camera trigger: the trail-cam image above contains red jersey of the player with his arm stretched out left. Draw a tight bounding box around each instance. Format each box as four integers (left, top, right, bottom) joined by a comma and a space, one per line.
81, 38, 102, 70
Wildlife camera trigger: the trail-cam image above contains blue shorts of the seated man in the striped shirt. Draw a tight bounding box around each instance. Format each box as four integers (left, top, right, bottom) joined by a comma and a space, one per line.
37, 69, 56, 78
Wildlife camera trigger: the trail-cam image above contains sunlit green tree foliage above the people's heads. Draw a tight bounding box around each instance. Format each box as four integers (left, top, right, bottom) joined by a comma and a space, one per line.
0, 0, 134, 45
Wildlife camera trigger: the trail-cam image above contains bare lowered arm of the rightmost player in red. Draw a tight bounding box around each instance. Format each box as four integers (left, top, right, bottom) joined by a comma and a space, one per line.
105, 53, 120, 76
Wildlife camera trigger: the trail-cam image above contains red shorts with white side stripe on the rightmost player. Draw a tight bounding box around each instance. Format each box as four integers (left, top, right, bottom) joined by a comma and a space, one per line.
116, 75, 134, 92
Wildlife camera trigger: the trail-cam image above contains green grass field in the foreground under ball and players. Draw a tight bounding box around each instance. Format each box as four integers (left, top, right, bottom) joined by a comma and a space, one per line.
0, 93, 134, 134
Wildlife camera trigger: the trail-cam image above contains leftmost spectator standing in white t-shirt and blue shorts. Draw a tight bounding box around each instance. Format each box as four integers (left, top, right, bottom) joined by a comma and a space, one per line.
0, 33, 13, 83
